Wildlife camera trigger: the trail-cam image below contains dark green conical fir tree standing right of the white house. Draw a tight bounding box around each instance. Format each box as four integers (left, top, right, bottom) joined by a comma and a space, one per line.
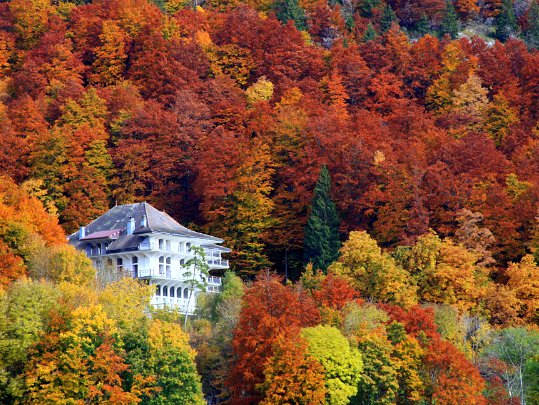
303, 166, 340, 271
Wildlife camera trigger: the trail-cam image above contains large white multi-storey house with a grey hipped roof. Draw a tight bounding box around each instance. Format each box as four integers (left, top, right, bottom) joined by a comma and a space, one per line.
69, 203, 230, 313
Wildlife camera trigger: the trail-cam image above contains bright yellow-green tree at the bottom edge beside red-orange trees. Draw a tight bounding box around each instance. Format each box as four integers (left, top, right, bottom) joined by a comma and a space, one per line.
301, 325, 363, 405
